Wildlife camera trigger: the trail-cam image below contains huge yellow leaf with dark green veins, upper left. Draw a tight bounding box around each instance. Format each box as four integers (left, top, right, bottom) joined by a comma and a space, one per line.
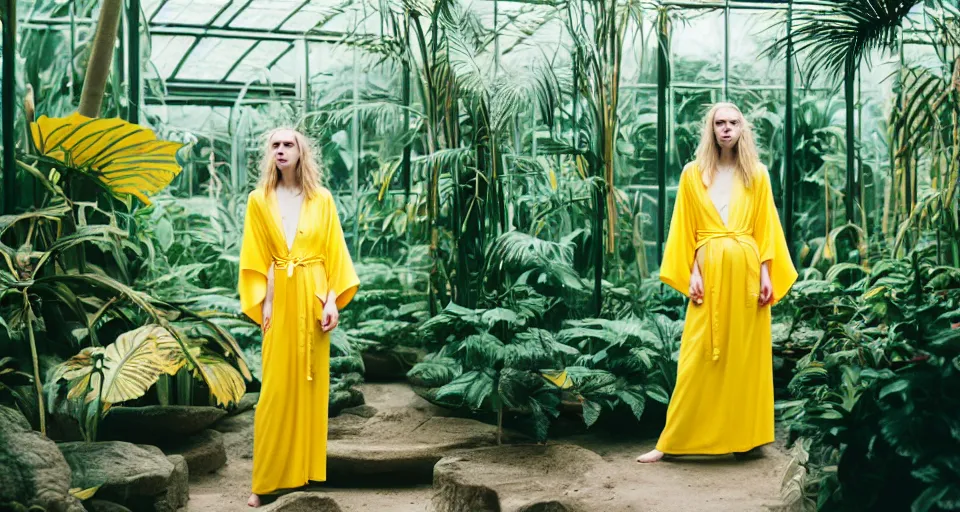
30, 113, 183, 204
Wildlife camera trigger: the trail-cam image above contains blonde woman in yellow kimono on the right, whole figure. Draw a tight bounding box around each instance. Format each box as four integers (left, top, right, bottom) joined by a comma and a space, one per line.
637, 103, 797, 463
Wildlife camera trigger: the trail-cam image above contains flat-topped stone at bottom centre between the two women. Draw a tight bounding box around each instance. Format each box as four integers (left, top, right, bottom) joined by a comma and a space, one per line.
433, 444, 609, 512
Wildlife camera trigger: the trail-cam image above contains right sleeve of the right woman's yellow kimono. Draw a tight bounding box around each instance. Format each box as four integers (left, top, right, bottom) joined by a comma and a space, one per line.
753, 168, 797, 304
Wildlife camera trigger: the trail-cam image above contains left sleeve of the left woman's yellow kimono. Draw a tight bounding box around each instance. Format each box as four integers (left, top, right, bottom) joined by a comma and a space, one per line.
237, 192, 270, 324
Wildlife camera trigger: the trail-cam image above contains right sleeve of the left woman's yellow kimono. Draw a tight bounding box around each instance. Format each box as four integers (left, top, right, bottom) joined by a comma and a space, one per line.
320, 193, 360, 310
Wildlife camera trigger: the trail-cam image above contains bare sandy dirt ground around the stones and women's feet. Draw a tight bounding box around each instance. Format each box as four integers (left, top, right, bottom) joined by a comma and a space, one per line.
186, 384, 790, 512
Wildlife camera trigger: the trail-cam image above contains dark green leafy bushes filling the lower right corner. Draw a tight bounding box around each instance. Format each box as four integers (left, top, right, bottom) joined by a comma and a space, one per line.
778, 252, 960, 511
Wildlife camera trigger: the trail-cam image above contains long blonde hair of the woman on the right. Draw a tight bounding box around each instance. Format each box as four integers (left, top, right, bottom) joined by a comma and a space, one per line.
697, 103, 760, 188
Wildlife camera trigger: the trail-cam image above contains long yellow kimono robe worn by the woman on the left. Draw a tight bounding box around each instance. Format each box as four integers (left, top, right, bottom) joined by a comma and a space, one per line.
239, 189, 360, 494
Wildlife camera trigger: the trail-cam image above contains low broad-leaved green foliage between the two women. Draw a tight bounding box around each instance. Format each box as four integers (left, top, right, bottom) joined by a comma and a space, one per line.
408, 264, 682, 441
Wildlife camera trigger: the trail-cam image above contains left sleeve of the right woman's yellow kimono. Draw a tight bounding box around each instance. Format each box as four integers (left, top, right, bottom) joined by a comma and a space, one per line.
660, 166, 697, 297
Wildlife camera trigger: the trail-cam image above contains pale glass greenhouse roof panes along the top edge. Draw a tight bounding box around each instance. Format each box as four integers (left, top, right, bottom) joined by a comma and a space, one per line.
20, 0, 940, 87
